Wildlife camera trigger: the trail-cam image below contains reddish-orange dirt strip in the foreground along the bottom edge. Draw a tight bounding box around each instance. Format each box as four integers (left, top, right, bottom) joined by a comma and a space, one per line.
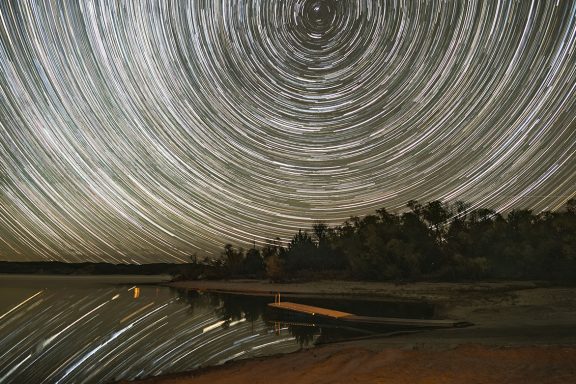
126, 345, 576, 384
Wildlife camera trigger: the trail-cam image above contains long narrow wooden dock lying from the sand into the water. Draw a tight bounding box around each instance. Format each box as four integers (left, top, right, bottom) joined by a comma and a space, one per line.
268, 300, 472, 328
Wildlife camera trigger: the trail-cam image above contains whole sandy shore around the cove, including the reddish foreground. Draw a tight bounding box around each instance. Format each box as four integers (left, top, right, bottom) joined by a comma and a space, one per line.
125, 281, 576, 384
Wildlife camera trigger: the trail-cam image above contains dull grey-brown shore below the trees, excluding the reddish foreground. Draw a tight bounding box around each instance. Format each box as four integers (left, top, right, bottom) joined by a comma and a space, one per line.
166, 280, 576, 345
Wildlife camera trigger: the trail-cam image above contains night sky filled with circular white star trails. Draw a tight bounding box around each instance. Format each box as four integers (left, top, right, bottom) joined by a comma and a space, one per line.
0, 0, 576, 262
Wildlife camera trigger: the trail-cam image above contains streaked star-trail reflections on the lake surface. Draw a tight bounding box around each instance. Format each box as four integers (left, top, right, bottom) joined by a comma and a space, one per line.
0, 280, 310, 383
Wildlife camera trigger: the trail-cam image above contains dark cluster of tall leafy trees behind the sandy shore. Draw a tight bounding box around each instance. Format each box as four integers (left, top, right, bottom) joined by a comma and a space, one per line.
181, 199, 576, 281
